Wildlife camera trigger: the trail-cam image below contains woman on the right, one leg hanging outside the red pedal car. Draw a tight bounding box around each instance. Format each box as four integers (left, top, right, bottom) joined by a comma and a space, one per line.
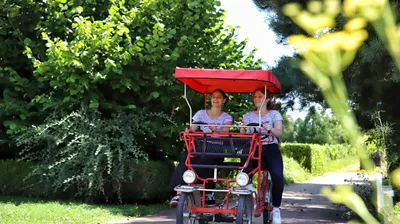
240, 88, 284, 224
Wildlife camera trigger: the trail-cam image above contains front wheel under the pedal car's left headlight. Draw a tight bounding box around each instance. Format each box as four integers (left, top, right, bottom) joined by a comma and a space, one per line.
176, 192, 197, 224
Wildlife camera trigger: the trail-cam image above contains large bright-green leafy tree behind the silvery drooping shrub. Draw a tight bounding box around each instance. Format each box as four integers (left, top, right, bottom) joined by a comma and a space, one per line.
0, 0, 261, 160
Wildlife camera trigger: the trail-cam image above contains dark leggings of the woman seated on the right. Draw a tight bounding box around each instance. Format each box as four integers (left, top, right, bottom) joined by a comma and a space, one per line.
244, 144, 284, 207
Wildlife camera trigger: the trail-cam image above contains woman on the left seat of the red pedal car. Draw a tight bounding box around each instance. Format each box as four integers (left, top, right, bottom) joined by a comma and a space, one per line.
168, 89, 233, 206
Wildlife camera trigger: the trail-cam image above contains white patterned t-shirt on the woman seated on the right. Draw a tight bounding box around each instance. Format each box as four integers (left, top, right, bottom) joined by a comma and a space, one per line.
242, 110, 283, 145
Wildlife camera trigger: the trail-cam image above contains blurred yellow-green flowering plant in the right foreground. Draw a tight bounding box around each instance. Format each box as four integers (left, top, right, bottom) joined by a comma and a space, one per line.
272, 0, 400, 223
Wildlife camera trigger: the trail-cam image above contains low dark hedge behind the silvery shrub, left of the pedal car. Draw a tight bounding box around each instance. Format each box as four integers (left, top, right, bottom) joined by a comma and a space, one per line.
0, 160, 175, 203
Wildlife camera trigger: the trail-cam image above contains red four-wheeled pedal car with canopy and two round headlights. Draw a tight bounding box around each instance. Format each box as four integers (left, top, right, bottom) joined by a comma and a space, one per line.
175, 68, 280, 224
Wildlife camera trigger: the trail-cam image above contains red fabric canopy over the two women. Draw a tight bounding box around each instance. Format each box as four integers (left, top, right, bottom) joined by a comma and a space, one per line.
175, 68, 281, 94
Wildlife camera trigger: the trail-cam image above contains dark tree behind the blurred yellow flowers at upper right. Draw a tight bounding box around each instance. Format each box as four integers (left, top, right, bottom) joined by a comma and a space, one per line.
253, 0, 400, 170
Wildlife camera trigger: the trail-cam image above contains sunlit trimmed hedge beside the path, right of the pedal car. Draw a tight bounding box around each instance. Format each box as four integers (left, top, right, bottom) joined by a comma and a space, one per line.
281, 143, 355, 175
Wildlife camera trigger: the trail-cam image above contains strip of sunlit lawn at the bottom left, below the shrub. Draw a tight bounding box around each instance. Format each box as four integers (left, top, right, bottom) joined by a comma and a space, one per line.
0, 196, 168, 224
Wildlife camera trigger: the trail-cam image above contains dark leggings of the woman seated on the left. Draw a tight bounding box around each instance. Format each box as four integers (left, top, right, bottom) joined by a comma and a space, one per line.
168, 153, 224, 193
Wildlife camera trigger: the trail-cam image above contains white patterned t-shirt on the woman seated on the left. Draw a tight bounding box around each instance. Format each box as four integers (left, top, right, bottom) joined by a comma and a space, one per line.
193, 110, 233, 132
